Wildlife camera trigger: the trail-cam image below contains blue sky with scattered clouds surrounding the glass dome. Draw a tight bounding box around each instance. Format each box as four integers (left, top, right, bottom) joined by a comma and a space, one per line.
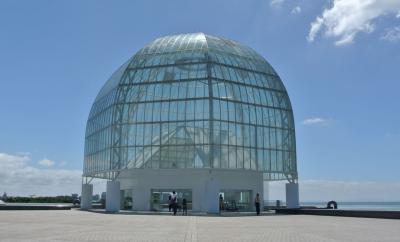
0, 0, 400, 201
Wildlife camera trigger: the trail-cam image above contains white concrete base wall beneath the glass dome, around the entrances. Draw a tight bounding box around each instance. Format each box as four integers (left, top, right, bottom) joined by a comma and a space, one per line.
117, 169, 263, 213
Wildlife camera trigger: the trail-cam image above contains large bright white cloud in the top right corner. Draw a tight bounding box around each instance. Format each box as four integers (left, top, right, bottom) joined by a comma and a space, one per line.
307, 0, 400, 45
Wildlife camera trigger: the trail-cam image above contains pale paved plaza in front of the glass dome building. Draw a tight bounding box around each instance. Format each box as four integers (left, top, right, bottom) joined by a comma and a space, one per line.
0, 210, 400, 242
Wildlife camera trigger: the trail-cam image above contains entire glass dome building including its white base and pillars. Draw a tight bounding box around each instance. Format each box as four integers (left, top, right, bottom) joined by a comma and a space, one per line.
82, 33, 298, 212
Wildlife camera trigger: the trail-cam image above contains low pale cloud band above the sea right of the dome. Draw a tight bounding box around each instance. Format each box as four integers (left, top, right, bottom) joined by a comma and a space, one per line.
268, 180, 400, 202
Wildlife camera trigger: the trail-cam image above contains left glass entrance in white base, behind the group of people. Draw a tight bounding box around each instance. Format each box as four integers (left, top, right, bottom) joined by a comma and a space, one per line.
150, 189, 192, 212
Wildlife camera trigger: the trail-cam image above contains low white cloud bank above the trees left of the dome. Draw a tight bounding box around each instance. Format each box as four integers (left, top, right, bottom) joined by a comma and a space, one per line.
0, 153, 104, 196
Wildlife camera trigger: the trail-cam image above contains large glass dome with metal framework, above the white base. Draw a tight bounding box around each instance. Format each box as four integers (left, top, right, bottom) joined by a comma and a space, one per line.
84, 33, 297, 180
